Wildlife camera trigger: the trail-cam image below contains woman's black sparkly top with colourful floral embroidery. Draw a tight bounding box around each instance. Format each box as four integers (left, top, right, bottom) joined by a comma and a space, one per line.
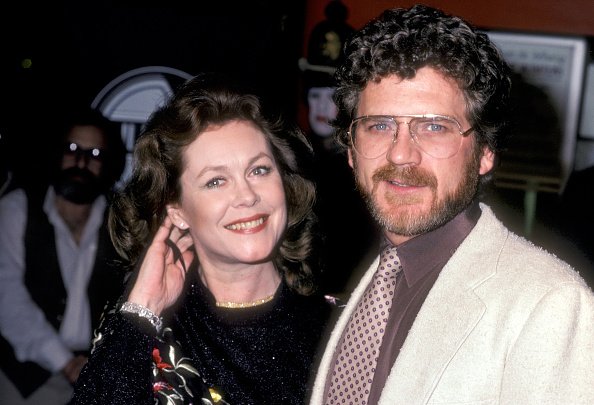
71, 281, 333, 405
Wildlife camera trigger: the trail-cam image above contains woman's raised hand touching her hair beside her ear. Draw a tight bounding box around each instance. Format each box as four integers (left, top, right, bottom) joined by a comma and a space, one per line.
128, 216, 194, 315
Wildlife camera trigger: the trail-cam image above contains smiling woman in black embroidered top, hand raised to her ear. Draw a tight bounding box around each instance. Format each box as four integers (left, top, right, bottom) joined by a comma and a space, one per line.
73, 75, 331, 404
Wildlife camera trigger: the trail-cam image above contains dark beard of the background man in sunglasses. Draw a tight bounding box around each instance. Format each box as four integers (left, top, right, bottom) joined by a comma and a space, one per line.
53, 167, 103, 204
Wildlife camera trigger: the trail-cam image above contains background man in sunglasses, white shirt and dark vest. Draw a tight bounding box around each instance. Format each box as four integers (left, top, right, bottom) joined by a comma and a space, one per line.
0, 105, 126, 404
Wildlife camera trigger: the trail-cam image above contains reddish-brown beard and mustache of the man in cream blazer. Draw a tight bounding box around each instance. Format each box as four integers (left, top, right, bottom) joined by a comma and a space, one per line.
353, 147, 482, 237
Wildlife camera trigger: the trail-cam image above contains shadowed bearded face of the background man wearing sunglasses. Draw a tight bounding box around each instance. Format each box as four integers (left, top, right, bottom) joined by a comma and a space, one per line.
54, 126, 106, 204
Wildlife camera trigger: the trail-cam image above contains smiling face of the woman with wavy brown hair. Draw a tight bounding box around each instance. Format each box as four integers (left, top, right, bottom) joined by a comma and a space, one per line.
169, 117, 287, 267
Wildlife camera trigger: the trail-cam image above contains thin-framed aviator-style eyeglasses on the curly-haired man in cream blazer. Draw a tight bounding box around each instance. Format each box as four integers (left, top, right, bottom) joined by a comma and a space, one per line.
348, 114, 473, 159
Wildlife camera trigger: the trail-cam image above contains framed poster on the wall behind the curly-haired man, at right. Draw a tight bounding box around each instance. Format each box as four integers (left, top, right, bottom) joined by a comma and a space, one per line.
487, 31, 587, 192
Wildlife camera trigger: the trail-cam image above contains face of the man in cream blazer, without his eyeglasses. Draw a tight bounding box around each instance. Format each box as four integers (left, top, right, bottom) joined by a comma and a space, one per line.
348, 68, 494, 245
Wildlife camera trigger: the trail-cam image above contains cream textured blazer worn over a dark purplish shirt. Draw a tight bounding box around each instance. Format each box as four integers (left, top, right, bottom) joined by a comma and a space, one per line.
310, 204, 594, 405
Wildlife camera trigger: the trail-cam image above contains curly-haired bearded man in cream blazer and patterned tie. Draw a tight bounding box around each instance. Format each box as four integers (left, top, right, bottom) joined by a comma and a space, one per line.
311, 6, 594, 405
